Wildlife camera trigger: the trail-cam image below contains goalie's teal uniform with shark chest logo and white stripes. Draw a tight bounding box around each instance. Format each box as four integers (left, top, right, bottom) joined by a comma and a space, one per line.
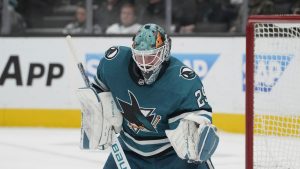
95, 46, 212, 169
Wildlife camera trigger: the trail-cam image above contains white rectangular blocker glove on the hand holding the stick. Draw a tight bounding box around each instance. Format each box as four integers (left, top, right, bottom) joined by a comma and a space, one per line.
76, 87, 123, 149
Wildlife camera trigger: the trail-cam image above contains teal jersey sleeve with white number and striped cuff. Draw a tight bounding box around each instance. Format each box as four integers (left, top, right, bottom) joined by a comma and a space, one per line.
168, 77, 212, 129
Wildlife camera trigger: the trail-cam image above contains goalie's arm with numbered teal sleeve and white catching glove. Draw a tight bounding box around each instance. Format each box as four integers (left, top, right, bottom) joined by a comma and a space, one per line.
166, 76, 219, 162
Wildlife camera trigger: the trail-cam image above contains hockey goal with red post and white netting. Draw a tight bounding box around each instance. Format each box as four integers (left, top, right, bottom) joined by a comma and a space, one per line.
246, 15, 300, 169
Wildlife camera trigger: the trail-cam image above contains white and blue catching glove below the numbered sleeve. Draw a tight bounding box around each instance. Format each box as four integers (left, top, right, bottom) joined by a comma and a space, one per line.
166, 114, 219, 163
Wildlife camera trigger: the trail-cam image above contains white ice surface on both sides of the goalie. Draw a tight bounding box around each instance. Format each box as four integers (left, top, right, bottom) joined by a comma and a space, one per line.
0, 128, 245, 169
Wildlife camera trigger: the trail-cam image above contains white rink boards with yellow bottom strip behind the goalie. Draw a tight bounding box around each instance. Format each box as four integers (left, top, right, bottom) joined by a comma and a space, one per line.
0, 37, 251, 133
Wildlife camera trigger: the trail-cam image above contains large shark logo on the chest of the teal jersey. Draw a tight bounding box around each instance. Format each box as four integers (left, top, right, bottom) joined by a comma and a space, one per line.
117, 90, 161, 133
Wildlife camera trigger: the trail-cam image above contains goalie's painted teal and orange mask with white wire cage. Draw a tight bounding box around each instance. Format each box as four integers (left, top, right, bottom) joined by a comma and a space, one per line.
132, 24, 171, 85
